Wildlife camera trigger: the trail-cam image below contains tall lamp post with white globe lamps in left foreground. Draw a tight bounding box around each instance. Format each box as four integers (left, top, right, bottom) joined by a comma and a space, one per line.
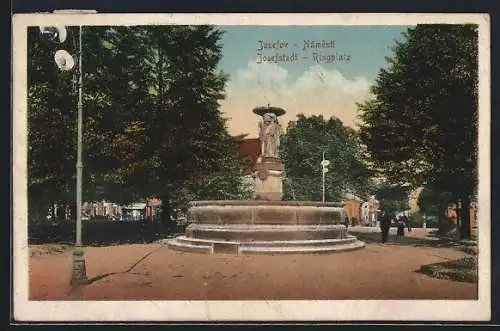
40, 25, 88, 285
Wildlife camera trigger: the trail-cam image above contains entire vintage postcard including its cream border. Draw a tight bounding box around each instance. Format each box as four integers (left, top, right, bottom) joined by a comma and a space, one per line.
12, 11, 491, 322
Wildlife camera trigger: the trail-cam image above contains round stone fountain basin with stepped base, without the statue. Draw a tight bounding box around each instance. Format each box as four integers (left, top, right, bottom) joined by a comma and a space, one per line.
168, 200, 365, 254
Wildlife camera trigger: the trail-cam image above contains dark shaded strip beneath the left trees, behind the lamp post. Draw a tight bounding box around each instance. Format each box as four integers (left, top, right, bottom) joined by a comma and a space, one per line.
28, 220, 184, 246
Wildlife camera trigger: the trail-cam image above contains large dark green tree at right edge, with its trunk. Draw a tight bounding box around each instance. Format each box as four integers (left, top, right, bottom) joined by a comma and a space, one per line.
358, 25, 478, 238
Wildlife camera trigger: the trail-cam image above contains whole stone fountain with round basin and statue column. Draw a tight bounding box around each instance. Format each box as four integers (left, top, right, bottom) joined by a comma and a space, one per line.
168, 105, 365, 254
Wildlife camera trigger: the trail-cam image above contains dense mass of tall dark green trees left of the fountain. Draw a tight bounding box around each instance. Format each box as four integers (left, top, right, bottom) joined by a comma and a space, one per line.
28, 26, 245, 226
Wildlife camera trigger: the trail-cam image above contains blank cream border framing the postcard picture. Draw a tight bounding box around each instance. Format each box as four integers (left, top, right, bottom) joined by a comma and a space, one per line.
13, 13, 491, 322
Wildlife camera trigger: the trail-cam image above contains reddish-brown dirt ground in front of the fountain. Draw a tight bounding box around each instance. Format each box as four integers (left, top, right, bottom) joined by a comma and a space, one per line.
29, 236, 477, 300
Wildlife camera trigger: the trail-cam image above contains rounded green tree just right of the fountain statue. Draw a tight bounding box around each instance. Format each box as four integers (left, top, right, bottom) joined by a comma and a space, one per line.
280, 115, 373, 201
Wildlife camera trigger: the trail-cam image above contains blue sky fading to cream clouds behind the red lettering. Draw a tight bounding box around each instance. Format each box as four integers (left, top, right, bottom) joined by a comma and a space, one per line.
219, 26, 408, 138
